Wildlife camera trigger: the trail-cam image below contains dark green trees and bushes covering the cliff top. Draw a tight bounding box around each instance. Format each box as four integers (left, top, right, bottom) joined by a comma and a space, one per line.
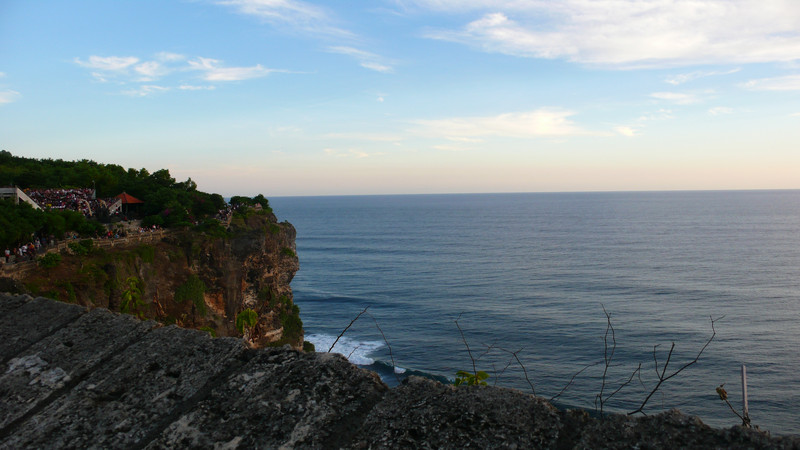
0, 150, 260, 248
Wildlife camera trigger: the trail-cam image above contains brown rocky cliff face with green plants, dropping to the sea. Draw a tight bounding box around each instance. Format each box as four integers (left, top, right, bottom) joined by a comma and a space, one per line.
4, 209, 303, 348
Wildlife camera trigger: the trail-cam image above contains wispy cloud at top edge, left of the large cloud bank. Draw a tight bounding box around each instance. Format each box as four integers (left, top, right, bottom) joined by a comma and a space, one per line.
214, 0, 352, 36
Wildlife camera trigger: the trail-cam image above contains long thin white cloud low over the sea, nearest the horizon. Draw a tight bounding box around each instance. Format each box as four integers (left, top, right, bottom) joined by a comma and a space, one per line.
416, 109, 596, 140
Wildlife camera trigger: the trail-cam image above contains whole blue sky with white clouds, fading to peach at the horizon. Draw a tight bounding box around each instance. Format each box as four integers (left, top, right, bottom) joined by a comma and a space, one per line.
0, 0, 800, 197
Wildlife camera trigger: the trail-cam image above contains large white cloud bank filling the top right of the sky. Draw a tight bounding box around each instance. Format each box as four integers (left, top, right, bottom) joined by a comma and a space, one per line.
416, 0, 800, 68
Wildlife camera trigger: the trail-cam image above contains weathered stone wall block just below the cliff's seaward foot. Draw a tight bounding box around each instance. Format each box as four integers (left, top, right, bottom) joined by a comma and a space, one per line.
149, 349, 388, 449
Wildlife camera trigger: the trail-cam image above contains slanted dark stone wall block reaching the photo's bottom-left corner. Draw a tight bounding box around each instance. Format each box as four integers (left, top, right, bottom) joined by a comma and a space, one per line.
4, 326, 245, 448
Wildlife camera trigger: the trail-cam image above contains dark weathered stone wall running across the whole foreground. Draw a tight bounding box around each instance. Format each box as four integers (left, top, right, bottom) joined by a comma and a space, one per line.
0, 294, 800, 449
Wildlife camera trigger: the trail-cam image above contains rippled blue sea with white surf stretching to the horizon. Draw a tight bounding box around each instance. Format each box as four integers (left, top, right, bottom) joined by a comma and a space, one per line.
271, 191, 800, 433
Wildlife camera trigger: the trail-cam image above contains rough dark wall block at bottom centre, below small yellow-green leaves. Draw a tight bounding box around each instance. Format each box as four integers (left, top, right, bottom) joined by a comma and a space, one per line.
353, 377, 560, 448
